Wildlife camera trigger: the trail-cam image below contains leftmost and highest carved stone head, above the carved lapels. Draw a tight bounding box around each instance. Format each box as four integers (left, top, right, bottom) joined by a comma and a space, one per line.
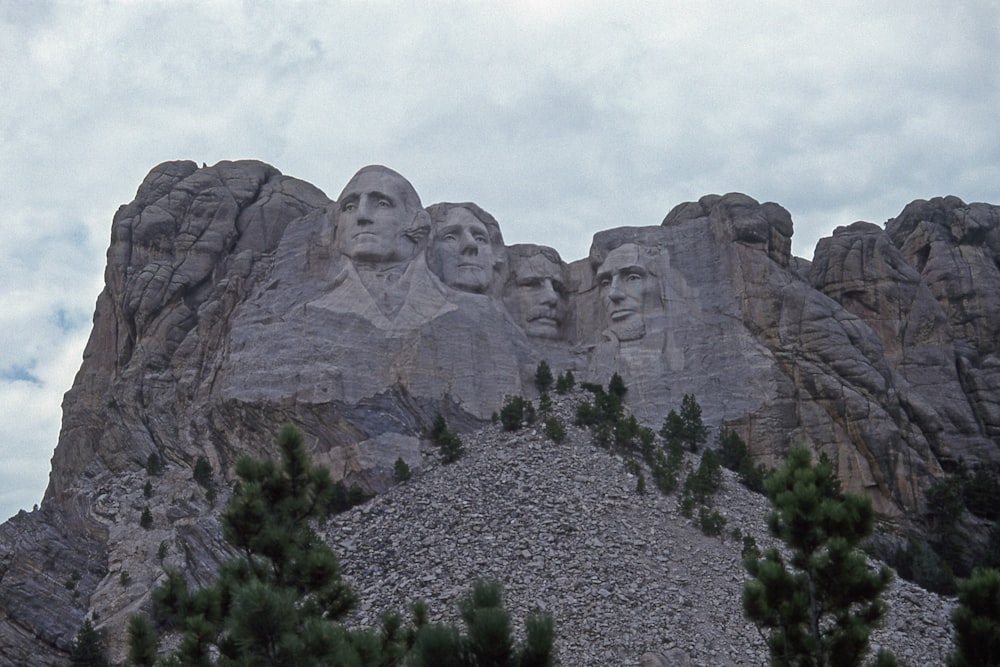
337, 169, 415, 263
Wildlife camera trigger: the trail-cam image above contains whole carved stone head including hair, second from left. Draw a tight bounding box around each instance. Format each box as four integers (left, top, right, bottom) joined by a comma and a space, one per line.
427, 203, 504, 294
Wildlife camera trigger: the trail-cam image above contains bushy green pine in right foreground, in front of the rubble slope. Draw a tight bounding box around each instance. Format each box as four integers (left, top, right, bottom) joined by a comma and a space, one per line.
743, 447, 893, 667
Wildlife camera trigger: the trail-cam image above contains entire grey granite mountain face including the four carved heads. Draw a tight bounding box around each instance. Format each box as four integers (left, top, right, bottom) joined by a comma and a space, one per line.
0, 161, 1000, 664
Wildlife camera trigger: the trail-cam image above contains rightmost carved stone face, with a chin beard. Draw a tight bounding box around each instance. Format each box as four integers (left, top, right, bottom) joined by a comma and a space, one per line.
597, 243, 660, 340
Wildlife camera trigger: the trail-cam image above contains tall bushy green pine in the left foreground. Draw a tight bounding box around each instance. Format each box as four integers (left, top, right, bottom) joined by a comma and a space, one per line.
130, 426, 368, 665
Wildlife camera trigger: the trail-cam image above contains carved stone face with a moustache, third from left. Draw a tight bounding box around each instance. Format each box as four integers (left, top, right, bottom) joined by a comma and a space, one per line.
504, 253, 566, 338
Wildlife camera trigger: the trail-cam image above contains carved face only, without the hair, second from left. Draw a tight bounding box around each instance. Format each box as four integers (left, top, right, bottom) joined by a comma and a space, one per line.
431, 208, 494, 292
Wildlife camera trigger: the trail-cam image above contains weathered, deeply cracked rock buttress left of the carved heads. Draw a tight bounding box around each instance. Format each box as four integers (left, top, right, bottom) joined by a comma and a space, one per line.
46, 162, 329, 501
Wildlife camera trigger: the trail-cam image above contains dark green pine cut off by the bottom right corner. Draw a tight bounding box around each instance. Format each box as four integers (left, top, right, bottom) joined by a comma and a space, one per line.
948, 568, 1000, 667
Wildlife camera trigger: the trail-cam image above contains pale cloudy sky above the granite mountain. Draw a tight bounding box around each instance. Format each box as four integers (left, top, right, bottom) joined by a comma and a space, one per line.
0, 0, 1000, 520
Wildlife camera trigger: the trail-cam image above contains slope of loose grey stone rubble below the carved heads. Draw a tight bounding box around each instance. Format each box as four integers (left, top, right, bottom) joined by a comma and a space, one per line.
324, 393, 953, 666
